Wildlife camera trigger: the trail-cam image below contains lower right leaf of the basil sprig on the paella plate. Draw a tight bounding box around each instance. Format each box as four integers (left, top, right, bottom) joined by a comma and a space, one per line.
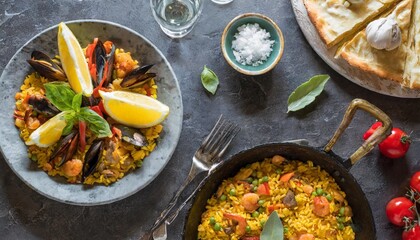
79, 107, 112, 138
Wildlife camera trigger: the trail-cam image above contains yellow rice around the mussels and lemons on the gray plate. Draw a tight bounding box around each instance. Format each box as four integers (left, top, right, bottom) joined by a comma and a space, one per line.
14, 49, 163, 185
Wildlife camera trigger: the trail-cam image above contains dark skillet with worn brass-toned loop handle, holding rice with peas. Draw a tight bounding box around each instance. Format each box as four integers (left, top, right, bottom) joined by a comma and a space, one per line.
184, 99, 392, 240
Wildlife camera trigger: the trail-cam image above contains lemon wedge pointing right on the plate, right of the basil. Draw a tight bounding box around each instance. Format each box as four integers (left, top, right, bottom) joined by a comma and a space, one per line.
99, 91, 169, 128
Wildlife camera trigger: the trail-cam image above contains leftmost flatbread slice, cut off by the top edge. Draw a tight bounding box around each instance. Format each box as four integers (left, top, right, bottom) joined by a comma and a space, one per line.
304, 0, 399, 48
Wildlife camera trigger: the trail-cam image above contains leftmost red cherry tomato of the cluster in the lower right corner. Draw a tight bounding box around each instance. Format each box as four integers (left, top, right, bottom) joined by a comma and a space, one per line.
385, 197, 414, 226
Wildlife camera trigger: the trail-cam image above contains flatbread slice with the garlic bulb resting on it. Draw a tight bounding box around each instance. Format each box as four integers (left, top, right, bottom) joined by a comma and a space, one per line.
339, 0, 414, 85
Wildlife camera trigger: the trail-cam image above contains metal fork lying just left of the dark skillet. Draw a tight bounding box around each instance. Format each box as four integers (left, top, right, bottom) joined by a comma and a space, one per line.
141, 115, 240, 240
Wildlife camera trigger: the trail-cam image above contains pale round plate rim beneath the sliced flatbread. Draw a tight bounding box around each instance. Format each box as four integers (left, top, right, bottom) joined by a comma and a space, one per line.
291, 0, 420, 98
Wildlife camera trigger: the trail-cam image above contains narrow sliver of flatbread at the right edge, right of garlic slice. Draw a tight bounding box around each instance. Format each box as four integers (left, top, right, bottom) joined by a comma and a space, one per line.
403, 0, 420, 88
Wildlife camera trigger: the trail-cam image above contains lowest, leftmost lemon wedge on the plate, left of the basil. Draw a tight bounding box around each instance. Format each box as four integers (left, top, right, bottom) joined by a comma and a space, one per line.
25, 112, 66, 147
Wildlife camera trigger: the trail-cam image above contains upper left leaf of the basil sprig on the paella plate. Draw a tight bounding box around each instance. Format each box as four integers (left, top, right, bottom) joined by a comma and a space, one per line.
44, 82, 76, 111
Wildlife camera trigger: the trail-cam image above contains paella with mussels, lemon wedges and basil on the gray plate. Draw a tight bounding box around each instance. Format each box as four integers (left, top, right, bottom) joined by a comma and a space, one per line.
14, 23, 169, 185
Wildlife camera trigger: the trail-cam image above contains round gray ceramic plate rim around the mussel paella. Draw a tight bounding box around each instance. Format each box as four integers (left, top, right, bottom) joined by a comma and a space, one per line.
0, 20, 182, 206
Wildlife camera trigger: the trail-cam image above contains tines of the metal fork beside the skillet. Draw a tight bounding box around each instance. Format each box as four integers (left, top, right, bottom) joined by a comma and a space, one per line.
200, 115, 240, 160
